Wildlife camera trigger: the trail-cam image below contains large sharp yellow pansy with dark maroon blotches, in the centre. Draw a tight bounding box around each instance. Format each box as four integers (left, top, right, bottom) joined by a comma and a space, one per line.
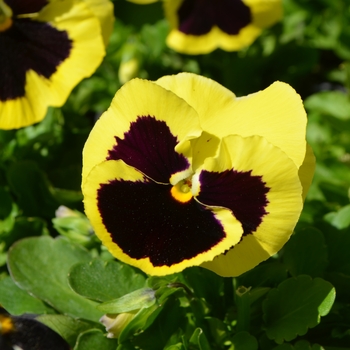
82, 73, 314, 276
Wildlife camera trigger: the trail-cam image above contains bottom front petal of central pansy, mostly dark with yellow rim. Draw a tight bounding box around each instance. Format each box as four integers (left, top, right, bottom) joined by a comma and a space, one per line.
82, 160, 242, 275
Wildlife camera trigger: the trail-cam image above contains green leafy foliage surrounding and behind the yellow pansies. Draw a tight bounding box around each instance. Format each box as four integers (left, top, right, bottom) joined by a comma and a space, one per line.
0, 0, 350, 350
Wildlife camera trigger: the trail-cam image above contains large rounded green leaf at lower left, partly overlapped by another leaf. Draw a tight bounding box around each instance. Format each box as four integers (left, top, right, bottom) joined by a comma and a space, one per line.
8, 237, 102, 321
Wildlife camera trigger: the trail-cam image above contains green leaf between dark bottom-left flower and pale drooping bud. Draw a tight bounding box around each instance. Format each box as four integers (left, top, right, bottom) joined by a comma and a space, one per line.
36, 315, 98, 350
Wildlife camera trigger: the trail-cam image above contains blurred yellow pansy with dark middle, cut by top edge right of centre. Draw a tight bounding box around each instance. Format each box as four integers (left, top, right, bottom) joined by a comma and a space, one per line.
165, 0, 282, 54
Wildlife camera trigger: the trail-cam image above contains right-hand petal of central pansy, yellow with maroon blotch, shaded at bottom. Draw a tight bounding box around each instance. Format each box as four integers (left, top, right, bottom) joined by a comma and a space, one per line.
194, 136, 302, 276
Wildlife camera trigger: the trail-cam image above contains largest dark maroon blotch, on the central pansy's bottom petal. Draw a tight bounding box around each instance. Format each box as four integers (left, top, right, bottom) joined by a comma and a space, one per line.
98, 180, 225, 266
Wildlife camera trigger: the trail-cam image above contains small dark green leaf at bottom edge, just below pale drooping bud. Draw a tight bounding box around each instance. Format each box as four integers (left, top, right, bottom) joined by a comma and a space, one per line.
74, 329, 118, 350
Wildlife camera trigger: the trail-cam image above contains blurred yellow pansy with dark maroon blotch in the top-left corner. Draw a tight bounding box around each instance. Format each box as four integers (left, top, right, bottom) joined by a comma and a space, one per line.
0, 0, 113, 129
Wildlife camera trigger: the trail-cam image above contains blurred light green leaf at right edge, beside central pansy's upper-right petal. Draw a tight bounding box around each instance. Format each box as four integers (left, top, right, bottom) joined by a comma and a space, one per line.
305, 91, 350, 120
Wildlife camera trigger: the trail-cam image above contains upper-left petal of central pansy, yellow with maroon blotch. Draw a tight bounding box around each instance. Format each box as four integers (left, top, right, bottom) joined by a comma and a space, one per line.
83, 79, 201, 183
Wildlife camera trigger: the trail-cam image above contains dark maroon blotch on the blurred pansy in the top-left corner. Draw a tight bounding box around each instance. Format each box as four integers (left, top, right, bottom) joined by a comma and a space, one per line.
0, 18, 72, 101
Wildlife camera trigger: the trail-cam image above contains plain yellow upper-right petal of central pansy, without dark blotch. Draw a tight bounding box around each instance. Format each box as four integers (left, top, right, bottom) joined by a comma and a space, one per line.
156, 73, 307, 167
